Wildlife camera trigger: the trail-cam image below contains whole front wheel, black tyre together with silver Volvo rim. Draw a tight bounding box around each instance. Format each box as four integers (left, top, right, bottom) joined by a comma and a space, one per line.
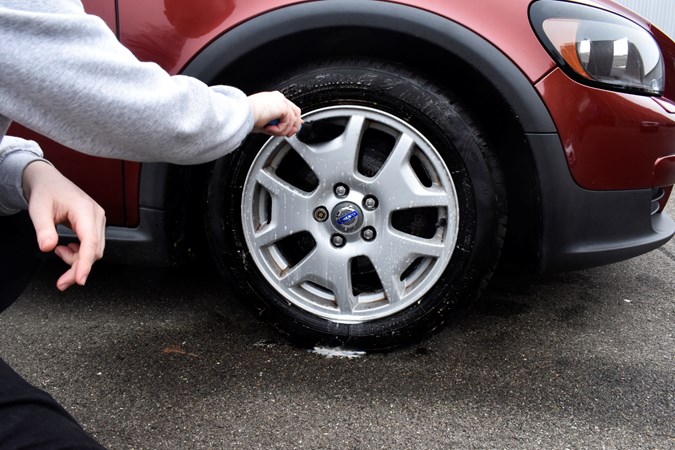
207, 60, 506, 351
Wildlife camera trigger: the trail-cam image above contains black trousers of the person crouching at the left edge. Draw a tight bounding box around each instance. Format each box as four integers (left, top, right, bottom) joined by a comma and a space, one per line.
0, 213, 104, 450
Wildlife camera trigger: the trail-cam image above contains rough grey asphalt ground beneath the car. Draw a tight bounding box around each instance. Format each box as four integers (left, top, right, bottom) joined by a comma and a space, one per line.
0, 205, 675, 450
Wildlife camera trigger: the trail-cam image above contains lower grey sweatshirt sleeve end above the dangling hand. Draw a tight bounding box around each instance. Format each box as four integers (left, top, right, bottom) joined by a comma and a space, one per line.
0, 136, 47, 216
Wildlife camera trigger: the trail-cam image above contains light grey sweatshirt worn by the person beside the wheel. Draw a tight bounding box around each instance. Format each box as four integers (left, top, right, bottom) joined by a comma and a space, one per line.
0, 0, 253, 214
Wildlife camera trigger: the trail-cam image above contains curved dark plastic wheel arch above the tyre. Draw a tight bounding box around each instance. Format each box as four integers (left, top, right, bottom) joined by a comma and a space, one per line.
181, 0, 556, 133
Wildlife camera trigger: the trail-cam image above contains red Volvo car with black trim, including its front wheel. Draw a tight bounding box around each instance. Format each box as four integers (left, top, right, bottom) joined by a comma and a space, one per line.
15, 0, 675, 350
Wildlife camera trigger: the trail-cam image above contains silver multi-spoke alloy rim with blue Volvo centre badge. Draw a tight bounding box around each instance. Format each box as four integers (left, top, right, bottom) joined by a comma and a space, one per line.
241, 106, 459, 323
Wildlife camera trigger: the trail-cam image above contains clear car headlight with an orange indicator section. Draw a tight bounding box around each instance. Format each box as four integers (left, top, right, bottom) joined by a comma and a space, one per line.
530, 0, 665, 95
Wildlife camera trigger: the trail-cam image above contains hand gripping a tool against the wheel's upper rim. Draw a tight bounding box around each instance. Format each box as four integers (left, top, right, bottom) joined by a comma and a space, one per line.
248, 91, 303, 137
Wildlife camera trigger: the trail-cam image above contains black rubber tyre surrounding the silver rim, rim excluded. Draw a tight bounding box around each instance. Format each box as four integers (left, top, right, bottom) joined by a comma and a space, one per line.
206, 59, 506, 351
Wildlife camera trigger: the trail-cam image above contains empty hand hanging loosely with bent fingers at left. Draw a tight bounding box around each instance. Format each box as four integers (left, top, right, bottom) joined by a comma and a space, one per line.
23, 161, 105, 291
